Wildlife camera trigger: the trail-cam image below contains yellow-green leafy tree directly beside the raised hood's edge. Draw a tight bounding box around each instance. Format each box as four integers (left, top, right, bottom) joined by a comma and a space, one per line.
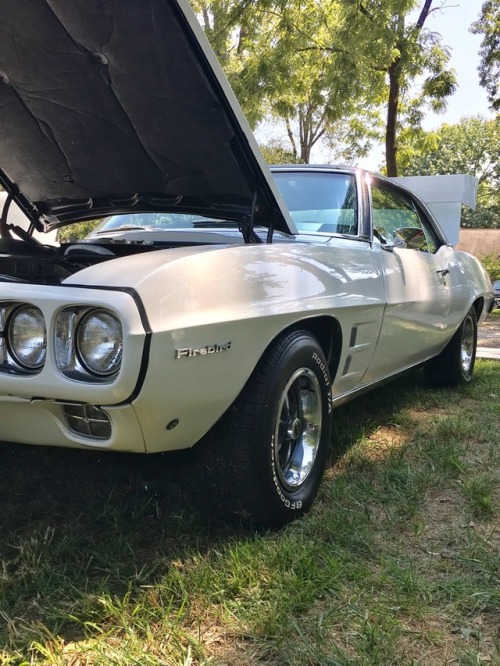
192, 0, 376, 162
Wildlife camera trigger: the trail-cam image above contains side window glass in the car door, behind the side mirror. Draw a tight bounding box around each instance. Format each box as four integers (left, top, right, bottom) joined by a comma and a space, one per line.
371, 183, 438, 253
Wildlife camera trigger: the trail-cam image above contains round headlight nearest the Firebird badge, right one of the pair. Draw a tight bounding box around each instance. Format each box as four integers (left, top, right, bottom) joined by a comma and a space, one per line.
76, 310, 123, 377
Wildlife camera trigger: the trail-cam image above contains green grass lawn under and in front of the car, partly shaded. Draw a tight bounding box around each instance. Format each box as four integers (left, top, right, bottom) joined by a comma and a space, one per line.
0, 361, 500, 666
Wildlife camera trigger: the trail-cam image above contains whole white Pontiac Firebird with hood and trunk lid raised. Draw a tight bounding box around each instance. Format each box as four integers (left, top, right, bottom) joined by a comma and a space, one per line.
0, 0, 493, 526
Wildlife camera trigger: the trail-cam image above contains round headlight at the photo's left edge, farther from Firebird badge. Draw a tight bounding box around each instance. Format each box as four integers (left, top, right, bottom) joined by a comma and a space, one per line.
7, 305, 47, 370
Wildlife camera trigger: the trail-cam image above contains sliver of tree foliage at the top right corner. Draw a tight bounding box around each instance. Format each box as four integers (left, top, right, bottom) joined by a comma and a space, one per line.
471, 0, 500, 111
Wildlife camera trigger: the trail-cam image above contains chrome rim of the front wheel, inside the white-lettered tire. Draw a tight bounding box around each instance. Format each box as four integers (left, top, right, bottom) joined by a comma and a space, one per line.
273, 368, 322, 490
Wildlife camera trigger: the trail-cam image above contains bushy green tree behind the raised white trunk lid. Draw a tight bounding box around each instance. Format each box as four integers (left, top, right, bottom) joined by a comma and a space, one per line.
400, 116, 500, 228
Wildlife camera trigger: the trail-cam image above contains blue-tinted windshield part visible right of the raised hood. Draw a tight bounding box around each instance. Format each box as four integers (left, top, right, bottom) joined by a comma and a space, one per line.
273, 171, 358, 236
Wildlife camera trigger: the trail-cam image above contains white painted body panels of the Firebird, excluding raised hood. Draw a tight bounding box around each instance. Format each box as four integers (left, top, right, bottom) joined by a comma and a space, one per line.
0, 167, 491, 452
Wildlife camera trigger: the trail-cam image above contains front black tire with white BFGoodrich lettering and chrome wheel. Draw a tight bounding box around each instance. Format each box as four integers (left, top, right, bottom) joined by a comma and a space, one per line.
197, 331, 332, 528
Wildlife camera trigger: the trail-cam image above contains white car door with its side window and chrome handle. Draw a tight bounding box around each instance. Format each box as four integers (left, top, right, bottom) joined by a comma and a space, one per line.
367, 179, 452, 380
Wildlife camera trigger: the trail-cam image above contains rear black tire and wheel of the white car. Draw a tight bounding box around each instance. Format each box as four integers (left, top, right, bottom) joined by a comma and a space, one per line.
425, 307, 477, 388
